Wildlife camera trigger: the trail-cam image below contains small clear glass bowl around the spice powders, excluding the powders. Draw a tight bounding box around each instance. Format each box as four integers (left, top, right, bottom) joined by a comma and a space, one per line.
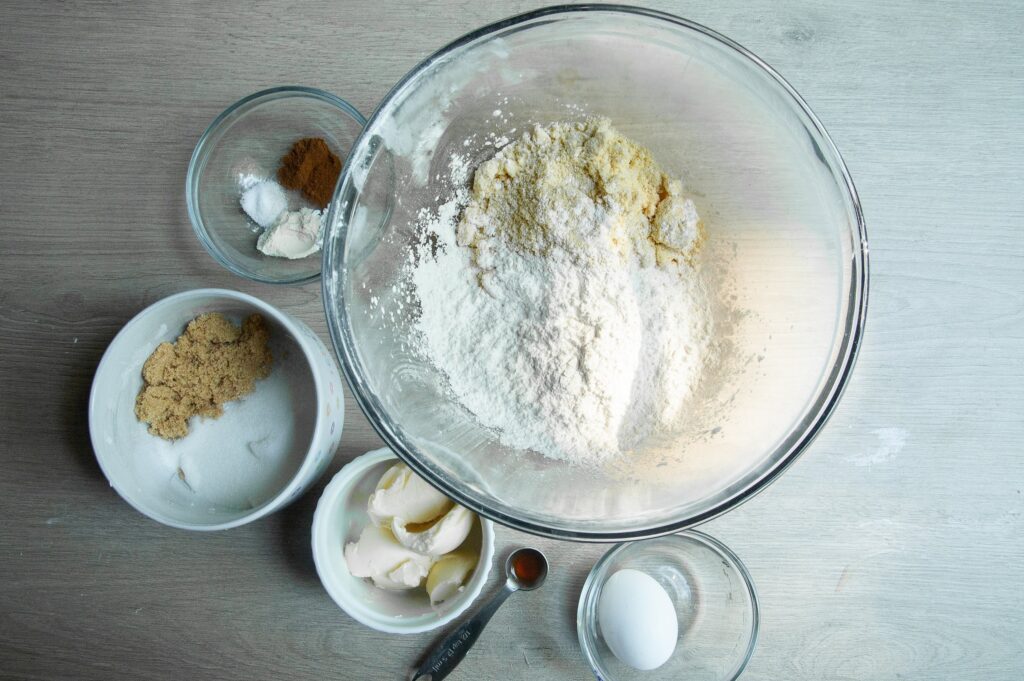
185, 86, 367, 284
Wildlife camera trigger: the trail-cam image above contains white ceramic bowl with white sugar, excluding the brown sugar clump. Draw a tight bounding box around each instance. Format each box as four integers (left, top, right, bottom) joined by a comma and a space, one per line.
89, 289, 344, 530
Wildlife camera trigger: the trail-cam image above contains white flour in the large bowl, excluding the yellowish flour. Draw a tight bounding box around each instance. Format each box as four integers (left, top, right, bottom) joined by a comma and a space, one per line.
412, 120, 711, 463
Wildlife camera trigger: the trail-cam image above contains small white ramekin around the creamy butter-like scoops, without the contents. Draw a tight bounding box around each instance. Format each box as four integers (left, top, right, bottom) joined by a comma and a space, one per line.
312, 449, 495, 634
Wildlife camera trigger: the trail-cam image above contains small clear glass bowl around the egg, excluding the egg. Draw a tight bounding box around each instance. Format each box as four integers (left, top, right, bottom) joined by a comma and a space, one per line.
577, 530, 759, 681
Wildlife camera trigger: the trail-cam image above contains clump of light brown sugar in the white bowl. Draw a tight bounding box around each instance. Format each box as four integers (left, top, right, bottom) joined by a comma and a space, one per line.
135, 312, 273, 439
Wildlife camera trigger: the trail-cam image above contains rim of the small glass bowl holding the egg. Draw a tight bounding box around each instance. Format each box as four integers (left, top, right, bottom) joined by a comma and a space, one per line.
577, 529, 761, 681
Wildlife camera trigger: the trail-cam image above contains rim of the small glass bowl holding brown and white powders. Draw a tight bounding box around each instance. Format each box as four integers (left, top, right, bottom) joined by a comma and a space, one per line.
185, 85, 367, 285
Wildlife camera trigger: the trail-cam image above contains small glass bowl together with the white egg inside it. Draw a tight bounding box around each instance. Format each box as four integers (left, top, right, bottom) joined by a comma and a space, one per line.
577, 530, 759, 681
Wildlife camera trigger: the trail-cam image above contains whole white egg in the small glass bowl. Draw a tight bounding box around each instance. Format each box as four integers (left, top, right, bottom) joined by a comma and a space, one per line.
597, 569, 679, 671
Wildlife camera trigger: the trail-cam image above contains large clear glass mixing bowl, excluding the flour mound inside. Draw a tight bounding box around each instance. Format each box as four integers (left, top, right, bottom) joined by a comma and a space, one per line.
323, 5, 867, 541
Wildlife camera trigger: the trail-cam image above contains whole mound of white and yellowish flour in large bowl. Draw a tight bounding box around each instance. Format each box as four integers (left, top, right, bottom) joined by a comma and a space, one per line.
410, 121, 712, 464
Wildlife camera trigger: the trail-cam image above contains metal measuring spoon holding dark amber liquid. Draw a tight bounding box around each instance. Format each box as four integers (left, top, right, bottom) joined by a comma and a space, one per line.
411, 549, 548, 681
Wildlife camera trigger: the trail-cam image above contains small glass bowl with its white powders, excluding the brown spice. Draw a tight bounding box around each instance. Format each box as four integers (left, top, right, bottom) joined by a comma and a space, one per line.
185, 86, 366, 284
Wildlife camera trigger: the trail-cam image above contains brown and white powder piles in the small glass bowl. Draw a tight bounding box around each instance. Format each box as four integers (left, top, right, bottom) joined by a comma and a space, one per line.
239, 137, 341, 260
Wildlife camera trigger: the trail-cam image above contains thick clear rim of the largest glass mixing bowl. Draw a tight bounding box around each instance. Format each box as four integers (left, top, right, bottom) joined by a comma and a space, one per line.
321, 4, 869, 543
